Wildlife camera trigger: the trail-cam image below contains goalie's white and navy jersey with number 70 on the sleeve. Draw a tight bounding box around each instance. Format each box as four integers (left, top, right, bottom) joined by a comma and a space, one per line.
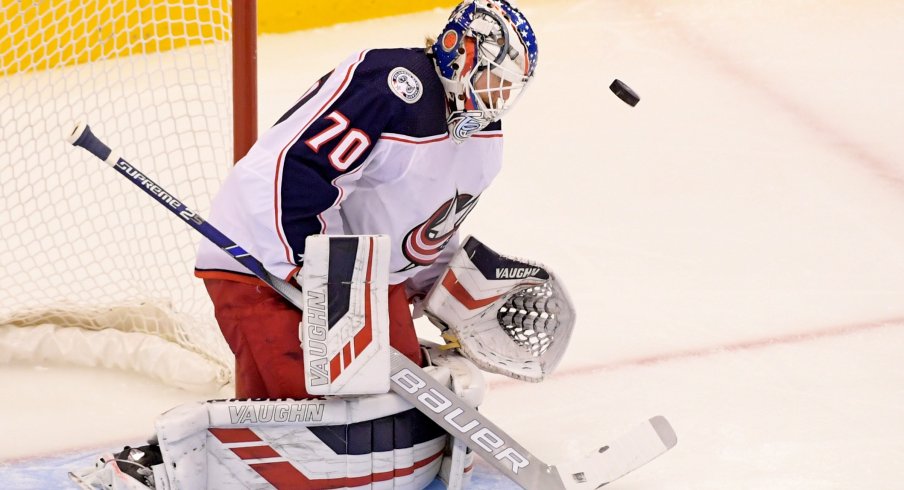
196, 49, 502, 291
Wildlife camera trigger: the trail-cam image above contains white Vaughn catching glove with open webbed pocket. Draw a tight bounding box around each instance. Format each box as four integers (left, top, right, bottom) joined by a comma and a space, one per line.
424, 237, 575, 382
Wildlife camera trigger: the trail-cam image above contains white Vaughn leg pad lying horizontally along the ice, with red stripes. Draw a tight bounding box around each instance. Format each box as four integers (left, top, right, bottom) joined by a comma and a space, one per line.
154, 367, 460, 490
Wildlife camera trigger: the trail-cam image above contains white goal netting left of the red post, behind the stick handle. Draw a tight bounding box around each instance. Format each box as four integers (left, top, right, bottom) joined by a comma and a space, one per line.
0, 0, 254, 391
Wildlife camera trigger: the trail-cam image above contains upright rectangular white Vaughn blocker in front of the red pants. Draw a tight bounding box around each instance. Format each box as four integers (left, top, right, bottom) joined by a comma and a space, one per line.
299, 235, 390, 395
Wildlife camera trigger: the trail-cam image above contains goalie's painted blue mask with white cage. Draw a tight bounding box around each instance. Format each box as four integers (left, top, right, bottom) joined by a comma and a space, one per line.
433, 0, 538, 143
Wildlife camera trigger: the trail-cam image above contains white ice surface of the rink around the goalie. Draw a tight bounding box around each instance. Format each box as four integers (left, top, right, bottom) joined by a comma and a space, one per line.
0, 0, 904, 489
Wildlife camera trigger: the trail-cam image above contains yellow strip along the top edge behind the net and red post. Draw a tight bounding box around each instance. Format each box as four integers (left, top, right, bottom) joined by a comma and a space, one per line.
0, 0, 457, 76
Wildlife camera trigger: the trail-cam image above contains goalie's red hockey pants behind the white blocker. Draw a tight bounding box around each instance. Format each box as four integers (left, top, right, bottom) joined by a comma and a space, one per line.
204, 279, 421, 398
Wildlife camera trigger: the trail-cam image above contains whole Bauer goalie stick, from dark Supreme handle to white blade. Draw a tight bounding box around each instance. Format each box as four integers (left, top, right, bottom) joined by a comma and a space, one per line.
67, 122, 677, 490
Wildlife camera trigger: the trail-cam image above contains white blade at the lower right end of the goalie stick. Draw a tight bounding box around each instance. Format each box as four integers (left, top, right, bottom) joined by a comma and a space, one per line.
555, 416, 678, 490
